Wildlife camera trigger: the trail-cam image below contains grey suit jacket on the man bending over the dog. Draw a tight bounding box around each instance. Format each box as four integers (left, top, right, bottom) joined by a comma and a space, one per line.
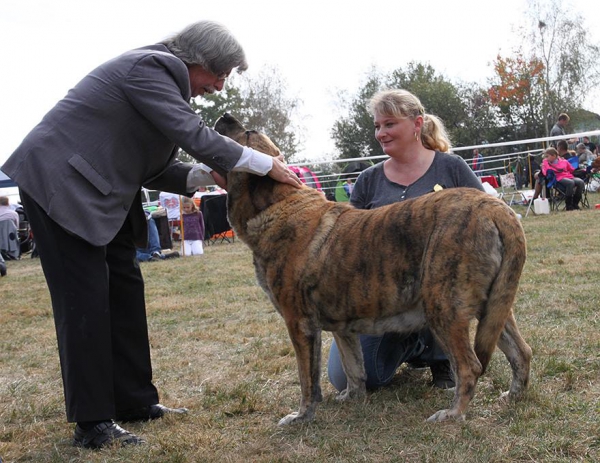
2, 44, 242, 246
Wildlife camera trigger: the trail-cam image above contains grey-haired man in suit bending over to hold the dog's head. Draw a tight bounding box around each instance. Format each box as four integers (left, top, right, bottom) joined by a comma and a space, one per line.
2, 21, 301, 448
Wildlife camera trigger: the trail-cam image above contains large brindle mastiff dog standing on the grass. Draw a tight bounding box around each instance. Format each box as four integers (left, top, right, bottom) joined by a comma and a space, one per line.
215, 114, 531, 424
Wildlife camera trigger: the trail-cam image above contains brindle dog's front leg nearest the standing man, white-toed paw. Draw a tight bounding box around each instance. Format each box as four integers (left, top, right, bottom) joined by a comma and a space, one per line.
279, 319, 323, 426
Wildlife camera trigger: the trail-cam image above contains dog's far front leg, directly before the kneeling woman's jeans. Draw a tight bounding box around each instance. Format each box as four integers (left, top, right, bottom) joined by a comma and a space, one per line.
333, 332, 367, 400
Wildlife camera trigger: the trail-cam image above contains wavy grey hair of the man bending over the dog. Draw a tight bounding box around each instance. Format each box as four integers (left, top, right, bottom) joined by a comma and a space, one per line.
161, 21, 248, 76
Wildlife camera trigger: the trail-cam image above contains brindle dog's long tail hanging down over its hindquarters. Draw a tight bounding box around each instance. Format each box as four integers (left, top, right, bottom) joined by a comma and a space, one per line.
474, 208, 527, 374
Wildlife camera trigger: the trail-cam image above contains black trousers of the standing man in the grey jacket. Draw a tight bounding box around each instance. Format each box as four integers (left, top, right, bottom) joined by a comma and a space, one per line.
21, 192, 158, 422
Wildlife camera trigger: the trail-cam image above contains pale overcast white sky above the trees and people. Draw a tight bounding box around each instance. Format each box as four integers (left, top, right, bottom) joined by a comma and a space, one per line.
0, 0, 600, 165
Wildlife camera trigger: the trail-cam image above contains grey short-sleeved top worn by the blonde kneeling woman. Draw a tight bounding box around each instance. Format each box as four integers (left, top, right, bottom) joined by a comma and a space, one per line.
350, 151, 484, 209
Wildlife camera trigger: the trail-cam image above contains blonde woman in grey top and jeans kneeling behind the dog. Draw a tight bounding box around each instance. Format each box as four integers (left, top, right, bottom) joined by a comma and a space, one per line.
328, 90, 483, 391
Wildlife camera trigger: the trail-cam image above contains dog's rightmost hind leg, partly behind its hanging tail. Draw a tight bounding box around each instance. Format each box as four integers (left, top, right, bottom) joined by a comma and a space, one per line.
498, 313, 532, 400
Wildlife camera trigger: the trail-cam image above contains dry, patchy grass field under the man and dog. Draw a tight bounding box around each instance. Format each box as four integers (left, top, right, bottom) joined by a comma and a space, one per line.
0, 204, 600, 463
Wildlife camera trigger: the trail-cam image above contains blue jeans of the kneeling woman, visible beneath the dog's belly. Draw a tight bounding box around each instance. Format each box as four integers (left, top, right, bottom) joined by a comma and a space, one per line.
327, 328, 448, 391
